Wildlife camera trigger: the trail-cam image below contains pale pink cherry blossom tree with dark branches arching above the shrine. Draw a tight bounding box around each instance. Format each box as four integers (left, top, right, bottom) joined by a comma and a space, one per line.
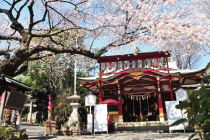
0, 0, 210, 81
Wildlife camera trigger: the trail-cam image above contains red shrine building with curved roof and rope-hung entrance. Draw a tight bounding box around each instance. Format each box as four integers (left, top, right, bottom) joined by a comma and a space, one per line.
78, 51, 210, 122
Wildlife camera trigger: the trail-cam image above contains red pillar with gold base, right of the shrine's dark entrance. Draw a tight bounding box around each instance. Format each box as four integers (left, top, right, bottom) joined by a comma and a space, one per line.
157, 76, 164, 121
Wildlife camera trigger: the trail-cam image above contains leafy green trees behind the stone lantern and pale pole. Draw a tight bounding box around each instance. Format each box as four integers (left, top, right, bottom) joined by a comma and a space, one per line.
17, 49, 96, 122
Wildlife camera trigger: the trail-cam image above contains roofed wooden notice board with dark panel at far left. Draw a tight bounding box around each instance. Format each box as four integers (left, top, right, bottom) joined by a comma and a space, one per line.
0, 74, 31, 131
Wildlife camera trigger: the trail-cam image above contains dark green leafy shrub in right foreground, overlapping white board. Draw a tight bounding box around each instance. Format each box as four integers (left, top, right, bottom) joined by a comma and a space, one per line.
170, 76, 210, 140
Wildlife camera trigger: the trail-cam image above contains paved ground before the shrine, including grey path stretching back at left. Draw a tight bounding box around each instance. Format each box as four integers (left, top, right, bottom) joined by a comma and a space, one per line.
21, 123, 199, 140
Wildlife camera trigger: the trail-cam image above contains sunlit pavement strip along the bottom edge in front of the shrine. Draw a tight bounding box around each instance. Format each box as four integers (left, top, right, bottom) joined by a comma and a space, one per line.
29, 132, 199, 140
